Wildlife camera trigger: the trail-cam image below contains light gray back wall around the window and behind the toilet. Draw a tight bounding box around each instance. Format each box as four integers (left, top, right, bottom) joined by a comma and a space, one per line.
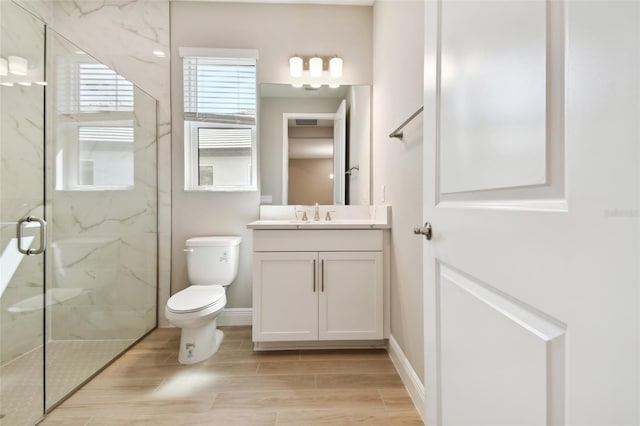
171, 2, 373, 308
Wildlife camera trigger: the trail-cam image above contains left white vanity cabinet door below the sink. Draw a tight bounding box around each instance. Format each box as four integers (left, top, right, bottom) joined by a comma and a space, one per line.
253, 252, 319, 342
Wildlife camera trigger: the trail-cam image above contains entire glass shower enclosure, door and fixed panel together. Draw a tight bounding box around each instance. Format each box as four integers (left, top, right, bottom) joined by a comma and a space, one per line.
0, 1, 157, 425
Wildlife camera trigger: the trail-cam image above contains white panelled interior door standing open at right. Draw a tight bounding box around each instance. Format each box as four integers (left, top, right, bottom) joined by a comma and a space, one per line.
424, 0, 640, 426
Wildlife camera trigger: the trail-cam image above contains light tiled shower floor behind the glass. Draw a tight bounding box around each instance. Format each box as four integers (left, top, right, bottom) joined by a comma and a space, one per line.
0, 340, 135, 426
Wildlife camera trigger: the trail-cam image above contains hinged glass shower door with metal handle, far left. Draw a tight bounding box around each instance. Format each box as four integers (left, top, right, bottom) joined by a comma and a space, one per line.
0, 1, 46, 425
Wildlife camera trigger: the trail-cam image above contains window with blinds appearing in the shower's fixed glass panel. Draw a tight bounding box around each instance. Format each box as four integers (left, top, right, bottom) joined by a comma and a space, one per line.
54, 55, 134, 191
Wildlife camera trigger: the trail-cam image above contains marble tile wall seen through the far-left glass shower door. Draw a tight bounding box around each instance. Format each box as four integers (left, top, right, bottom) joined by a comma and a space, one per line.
0, 4, 44, 364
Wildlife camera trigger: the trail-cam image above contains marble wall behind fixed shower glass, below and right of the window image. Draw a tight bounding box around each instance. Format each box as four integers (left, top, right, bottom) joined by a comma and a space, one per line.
49, 85, 157, 340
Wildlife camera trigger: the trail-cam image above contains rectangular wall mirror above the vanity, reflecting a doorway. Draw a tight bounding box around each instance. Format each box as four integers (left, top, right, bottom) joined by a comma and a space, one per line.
259, 84, 371, 205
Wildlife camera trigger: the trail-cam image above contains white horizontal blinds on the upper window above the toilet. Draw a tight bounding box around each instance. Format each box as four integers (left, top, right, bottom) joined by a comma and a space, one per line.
183, 56, 256, 126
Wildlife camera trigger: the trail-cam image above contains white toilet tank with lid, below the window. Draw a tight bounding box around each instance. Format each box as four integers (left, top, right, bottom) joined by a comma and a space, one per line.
185, 236, 242, 286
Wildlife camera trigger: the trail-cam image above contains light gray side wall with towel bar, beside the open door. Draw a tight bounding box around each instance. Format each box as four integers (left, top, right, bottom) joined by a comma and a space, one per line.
372, 0, 424, 378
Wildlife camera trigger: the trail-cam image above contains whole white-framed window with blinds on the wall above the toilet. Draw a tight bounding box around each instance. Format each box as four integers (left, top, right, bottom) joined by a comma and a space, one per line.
180, 48, 257, 191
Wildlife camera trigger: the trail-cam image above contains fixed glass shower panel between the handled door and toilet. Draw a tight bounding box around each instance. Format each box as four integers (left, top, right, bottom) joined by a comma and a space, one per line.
45, 29, 157, 411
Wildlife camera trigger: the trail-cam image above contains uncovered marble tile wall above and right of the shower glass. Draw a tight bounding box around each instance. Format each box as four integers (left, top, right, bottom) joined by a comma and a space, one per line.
16, 0, 171, 324
